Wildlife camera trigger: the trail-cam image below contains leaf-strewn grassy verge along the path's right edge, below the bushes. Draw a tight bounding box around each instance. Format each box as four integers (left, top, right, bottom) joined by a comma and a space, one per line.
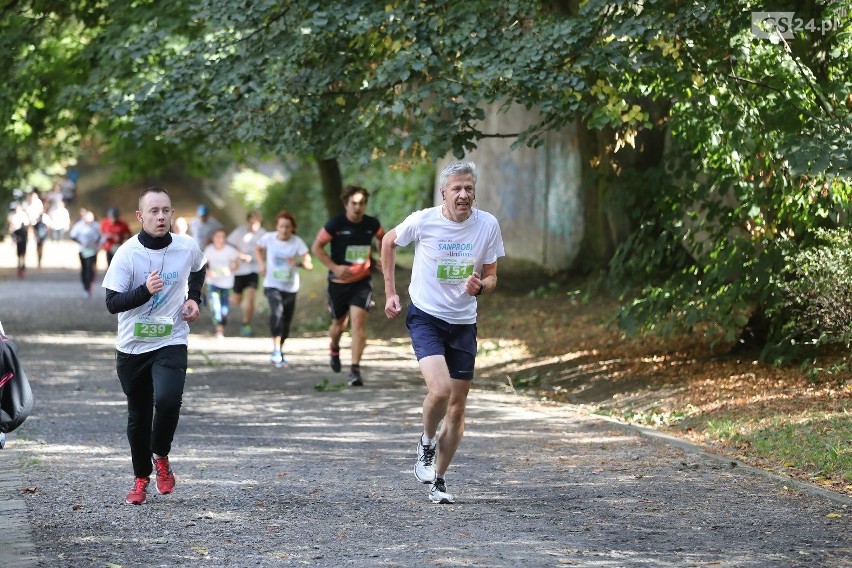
477, 263, 852, 494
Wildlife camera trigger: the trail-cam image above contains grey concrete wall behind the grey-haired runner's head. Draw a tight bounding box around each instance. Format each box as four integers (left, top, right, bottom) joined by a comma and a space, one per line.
435, 105, 583, 270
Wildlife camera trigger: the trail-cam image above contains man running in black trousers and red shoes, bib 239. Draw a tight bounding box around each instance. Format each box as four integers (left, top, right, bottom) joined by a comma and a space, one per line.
103, 187, 206, 505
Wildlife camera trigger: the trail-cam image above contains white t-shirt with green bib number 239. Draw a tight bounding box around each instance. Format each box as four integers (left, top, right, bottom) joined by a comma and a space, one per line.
103, 234, 207, 354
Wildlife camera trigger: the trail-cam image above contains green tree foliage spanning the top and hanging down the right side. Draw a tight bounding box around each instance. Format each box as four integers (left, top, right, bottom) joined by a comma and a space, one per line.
5, 0, 852, 355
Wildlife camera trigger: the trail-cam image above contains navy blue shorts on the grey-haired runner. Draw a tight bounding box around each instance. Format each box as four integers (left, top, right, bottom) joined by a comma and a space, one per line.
405, 304, 476, 381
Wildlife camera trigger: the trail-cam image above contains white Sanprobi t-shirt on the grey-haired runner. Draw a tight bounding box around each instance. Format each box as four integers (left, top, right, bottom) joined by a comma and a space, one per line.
395, 206, 506, 324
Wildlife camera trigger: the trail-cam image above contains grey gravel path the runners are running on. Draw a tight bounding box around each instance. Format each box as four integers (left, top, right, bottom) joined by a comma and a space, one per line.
0, 243, 852, 568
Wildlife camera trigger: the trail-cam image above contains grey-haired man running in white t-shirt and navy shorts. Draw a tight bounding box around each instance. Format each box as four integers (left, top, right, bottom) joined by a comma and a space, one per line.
382, 162, 505, 503
